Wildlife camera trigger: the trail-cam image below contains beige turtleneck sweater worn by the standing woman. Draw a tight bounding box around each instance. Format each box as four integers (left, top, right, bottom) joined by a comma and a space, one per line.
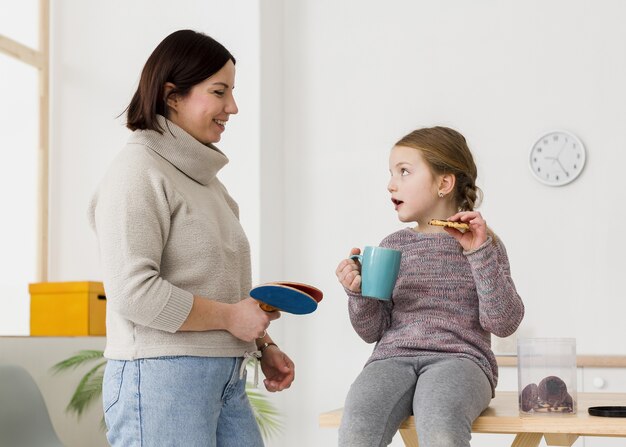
89, 116, 256, 360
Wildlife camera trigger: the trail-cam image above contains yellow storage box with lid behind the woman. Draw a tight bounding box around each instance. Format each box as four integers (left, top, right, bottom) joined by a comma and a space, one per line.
28, 281, 106, 336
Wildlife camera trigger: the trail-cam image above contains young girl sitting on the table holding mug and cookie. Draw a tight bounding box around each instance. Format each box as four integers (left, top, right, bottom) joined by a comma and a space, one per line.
336, 127, 524, 447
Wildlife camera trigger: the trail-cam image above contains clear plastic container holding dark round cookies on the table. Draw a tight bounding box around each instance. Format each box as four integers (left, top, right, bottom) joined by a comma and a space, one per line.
517, 338, 578, 415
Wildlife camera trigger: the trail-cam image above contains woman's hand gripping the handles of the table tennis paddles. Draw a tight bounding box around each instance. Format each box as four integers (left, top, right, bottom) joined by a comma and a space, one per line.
226, 298, 280, 342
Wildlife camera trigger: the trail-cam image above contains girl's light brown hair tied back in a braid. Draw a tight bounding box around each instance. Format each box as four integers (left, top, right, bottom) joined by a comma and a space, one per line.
396, 126, 482, 211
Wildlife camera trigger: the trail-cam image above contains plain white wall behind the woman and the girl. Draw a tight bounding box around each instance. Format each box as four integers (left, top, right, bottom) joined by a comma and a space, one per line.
3, 0, 626, 446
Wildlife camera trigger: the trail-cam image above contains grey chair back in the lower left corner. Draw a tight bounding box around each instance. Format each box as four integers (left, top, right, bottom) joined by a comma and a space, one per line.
0, 363, 63, 447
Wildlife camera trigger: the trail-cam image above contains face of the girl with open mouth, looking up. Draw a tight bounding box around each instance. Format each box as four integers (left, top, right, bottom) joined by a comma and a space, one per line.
387, 146, 446, 226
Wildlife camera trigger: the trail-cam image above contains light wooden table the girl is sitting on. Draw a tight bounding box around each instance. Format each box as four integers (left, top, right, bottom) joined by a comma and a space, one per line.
319, 391, 626, 447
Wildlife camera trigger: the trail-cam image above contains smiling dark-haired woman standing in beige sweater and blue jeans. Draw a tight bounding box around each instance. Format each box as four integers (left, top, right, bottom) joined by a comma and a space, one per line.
90, 30, 294, 446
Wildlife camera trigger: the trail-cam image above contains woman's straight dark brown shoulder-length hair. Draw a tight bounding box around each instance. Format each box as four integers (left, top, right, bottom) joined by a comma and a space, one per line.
126, 30, 235, 133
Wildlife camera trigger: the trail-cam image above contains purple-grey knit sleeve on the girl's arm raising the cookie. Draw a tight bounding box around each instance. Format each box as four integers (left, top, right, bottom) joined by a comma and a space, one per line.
465, 237, 524, 337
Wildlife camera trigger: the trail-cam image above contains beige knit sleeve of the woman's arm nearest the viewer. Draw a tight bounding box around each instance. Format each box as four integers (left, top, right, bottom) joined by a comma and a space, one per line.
90, 152, 193, 332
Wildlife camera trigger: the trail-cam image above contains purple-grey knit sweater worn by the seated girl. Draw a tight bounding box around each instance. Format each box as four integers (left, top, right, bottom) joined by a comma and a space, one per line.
347, 228, 524, 390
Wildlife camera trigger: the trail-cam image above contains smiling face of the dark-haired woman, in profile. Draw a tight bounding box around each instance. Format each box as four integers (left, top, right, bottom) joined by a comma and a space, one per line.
168, 60, 239, 144
